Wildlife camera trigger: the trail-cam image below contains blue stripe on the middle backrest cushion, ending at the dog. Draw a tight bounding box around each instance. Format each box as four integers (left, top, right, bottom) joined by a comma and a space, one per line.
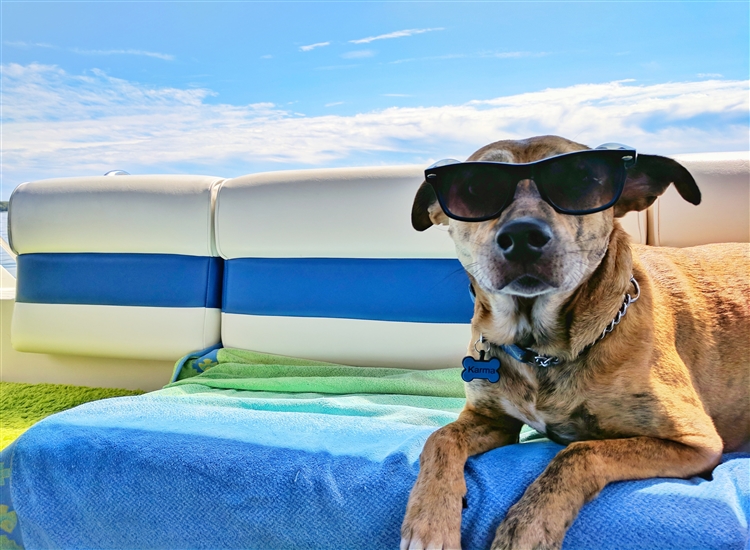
222, 258, 474, 323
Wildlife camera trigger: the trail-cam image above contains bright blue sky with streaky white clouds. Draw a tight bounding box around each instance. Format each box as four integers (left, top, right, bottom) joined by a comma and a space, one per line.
0, 0, 750, 200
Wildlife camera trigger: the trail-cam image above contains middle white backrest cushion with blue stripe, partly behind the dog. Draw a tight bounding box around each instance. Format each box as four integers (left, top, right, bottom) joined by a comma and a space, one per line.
216, 166, 646, 369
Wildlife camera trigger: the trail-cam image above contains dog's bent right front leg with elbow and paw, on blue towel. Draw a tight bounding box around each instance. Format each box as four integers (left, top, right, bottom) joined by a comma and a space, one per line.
492, 435, 722, 550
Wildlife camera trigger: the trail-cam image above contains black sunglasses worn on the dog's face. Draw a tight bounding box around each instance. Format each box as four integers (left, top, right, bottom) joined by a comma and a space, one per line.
425, 143, 636, 222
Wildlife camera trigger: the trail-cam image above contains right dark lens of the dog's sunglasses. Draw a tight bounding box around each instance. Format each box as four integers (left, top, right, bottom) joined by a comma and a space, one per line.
535, 154, 627, 213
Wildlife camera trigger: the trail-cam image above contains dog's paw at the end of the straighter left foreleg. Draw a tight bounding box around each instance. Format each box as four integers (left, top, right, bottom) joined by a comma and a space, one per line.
400, 487, 461, 550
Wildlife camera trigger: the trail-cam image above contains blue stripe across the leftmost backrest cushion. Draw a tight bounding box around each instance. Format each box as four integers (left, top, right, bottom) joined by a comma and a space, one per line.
16, 252, 223, 308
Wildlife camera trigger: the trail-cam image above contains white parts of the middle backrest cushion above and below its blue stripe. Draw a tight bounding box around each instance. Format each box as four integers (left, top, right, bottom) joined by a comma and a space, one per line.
216, 166, 470, 368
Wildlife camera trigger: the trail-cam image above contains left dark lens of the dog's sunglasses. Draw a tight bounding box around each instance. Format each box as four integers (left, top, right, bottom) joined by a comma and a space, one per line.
434, 164, 515, 219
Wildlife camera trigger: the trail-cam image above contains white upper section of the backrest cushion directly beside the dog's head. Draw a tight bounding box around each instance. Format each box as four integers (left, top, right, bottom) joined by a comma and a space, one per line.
216, 166, 456, 259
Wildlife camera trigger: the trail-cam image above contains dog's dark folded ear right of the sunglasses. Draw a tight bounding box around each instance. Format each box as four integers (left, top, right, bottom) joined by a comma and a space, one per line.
615, 155, 701, 218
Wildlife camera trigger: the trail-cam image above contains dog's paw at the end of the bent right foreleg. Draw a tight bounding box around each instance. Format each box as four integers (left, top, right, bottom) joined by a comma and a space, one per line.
492, 502, 565, 550
